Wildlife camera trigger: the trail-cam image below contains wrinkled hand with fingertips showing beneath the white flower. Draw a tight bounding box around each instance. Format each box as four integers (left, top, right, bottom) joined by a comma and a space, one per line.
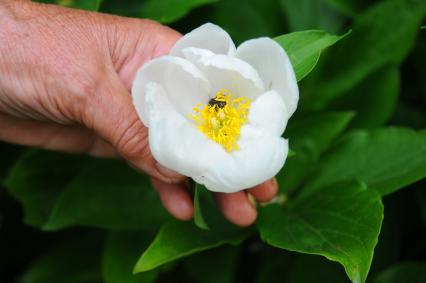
0, 0, 278, 226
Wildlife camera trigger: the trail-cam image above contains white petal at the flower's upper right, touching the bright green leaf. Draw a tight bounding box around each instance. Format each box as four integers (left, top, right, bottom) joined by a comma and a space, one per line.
236, 37, 299, 116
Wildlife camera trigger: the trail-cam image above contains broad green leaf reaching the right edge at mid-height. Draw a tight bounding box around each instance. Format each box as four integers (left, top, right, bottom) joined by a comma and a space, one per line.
302, 128, 426, 195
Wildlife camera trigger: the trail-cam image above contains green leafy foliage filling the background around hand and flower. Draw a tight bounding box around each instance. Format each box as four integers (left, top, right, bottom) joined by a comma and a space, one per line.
0, 0, 426, 283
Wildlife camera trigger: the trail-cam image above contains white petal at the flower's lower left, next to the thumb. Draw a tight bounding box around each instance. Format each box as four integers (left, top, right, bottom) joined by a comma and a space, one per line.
145, 84, 224, 177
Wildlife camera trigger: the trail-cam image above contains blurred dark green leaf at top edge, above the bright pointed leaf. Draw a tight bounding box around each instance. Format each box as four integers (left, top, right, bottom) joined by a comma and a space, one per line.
279, 0, 343, 33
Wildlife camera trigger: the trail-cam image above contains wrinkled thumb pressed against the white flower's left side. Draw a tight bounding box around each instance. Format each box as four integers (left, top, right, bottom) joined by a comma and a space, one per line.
85, 73, 184, 183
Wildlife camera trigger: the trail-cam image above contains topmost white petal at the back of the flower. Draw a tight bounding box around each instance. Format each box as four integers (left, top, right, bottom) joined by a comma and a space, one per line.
170, 23, 235, 57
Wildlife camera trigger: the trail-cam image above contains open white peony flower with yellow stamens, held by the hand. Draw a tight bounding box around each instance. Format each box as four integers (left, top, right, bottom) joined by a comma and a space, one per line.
132, 23, 299, 193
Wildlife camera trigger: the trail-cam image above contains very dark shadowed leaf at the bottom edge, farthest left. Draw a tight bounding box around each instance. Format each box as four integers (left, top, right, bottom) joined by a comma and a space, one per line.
20, 233, 102, 283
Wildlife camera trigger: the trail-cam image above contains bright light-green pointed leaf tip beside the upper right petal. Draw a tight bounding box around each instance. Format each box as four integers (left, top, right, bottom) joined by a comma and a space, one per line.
275, 30, 347, 81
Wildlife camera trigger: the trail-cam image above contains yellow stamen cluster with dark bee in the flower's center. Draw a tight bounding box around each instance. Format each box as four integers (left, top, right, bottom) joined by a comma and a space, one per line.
189, 89, 251, 152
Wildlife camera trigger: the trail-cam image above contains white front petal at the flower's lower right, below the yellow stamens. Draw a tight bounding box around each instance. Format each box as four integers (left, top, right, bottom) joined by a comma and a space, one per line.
194, 133, 288, 193
